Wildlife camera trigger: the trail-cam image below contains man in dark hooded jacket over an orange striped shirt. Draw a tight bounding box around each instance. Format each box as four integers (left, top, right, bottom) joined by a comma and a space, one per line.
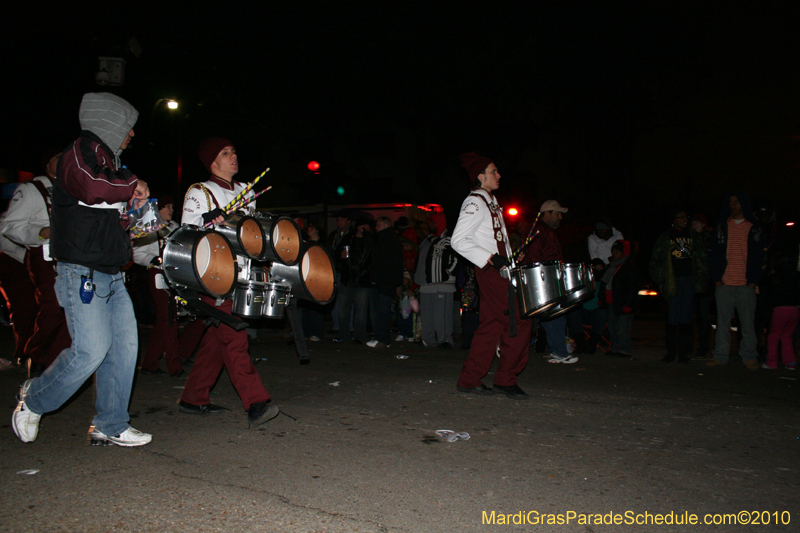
708, 191, 765, 370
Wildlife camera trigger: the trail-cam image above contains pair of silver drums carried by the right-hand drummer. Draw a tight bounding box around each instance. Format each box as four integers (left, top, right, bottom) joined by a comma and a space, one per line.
510, 261, 595, 320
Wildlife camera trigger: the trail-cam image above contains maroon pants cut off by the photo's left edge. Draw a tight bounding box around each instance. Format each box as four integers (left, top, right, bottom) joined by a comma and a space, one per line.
0, 253, 36, 361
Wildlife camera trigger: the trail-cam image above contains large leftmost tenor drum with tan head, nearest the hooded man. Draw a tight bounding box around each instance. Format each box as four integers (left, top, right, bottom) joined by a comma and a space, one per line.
161, 226, 237, 298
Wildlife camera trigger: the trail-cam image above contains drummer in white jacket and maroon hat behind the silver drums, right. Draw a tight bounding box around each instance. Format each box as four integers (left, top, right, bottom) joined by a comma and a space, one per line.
450, 152, 531, 400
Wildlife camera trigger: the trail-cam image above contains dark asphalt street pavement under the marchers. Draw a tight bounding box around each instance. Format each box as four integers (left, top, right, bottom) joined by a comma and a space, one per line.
0, 319, 800, 533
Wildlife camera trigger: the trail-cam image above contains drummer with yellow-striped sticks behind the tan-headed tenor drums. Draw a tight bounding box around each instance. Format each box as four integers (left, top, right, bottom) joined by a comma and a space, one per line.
179, 137, 280, 425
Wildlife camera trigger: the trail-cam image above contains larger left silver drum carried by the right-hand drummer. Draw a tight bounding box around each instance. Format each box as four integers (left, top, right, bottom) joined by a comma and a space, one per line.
510, 261, 566, 318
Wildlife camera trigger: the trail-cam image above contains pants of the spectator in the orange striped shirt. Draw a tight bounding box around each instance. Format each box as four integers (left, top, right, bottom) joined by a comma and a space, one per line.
711, 285, 758, 363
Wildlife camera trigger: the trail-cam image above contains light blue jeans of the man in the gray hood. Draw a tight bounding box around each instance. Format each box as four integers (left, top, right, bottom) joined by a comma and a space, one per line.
25, 263, 139, 435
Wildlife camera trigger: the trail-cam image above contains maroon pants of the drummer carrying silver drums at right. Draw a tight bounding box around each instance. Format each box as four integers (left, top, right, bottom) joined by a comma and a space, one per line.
458, 267, 531, 389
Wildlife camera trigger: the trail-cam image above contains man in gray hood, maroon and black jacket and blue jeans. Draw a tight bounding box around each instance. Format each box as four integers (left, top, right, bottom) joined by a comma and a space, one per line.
11, 93, 152, 446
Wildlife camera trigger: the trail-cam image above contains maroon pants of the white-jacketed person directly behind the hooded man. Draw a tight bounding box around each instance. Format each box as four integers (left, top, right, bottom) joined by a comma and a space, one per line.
25, 246, 72, 368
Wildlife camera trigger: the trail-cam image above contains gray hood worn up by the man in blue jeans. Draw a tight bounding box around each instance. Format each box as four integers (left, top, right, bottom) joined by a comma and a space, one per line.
78, 93, 139, 153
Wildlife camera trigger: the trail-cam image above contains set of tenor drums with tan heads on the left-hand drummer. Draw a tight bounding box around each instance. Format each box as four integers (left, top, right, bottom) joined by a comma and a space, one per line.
161, 214, 335, 318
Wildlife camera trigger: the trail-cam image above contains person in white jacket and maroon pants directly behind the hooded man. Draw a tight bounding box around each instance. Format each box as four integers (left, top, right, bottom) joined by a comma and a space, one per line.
2, 151, 72, 377
